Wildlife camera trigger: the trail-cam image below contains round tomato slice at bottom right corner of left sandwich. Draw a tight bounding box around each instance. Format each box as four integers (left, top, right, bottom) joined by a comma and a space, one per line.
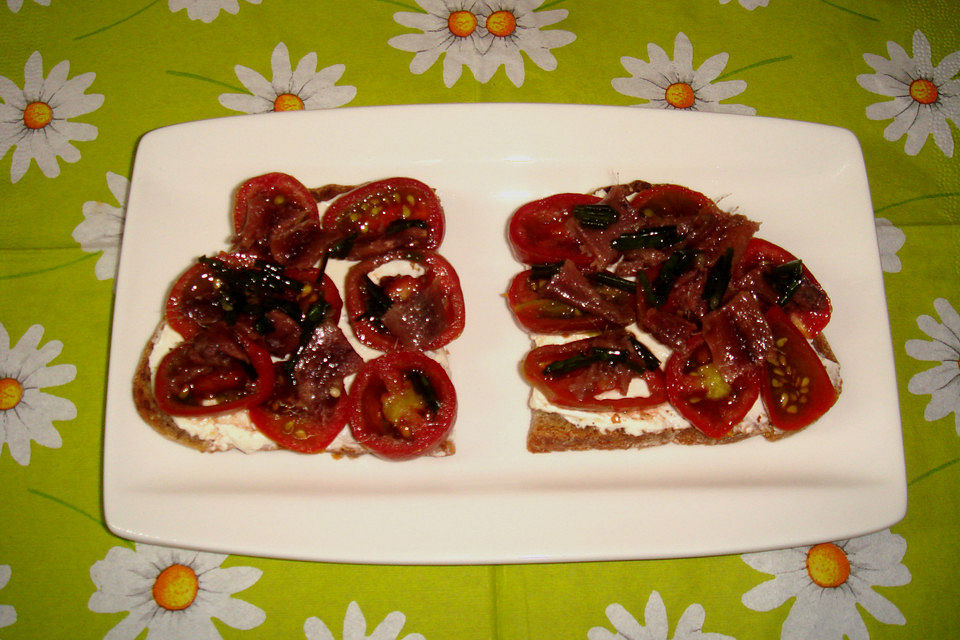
350, 351, 457, 460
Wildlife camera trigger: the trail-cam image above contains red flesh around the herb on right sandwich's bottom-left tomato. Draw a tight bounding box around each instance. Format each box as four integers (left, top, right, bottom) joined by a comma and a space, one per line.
522, 338, 667, 411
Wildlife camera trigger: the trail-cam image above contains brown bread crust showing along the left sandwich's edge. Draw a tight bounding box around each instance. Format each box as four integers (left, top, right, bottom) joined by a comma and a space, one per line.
133, 322, 456, 458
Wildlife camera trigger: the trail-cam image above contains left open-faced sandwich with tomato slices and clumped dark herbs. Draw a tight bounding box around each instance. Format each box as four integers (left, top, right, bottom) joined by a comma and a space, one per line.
133, 173, 464, 459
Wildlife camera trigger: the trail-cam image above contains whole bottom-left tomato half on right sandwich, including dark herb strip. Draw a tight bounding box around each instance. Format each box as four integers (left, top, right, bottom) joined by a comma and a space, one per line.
523, 332, 667, 411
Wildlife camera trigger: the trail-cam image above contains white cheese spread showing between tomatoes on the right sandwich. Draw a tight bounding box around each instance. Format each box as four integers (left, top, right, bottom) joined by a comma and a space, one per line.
528, 324, 840, 436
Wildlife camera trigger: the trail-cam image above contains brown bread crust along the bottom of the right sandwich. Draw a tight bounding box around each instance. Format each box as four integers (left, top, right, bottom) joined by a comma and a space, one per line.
527, 334, 842, 453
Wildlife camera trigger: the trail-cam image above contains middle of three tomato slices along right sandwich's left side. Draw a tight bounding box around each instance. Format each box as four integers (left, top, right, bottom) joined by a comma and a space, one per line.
507, 269, 636, 333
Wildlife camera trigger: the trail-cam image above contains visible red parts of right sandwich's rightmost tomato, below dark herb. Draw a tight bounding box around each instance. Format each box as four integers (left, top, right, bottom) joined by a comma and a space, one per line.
739, 238, 833, 338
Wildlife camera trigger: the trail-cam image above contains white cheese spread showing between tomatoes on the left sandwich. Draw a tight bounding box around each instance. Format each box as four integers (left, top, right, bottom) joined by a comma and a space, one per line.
149, 260, 449, 453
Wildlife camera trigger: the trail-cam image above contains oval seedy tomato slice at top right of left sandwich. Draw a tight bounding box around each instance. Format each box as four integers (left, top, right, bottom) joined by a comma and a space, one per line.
323, 178, 444, 260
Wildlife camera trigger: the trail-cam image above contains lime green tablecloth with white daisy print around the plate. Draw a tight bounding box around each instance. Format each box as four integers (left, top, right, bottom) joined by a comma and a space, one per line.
0, 0, 960, 640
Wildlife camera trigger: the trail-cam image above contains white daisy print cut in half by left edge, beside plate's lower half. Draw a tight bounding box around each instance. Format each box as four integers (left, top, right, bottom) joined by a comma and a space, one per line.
0, 324, 77, 466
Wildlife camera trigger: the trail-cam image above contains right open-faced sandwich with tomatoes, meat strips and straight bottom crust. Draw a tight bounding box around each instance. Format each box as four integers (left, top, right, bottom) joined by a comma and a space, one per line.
507, 180, 841, 452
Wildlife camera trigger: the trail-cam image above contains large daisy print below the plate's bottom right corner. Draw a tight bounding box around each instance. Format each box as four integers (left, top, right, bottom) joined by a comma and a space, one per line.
741, 530, 911, 640
